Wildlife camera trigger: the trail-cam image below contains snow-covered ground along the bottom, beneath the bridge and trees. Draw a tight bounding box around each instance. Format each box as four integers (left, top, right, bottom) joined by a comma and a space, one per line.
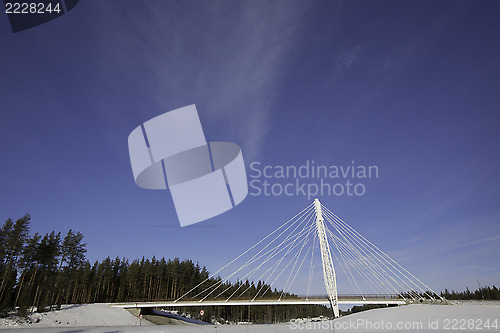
0, 301, 500, 333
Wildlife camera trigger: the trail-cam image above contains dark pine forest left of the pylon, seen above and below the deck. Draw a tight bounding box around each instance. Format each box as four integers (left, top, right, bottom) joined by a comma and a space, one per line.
0, 215, 329, 322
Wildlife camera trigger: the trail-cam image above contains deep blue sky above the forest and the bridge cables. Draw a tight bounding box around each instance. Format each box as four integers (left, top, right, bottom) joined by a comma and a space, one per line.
0, 0, 500, 290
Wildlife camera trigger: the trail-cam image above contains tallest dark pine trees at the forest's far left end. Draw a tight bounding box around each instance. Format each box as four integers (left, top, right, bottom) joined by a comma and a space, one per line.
0, 214, 87, 313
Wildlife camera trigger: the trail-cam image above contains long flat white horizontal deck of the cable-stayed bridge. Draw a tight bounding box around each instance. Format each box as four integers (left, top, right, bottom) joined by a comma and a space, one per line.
111, 298, 406, 308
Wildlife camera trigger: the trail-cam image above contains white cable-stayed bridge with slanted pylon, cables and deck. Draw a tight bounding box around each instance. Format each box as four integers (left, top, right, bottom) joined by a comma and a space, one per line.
114, 199, 444, 317
